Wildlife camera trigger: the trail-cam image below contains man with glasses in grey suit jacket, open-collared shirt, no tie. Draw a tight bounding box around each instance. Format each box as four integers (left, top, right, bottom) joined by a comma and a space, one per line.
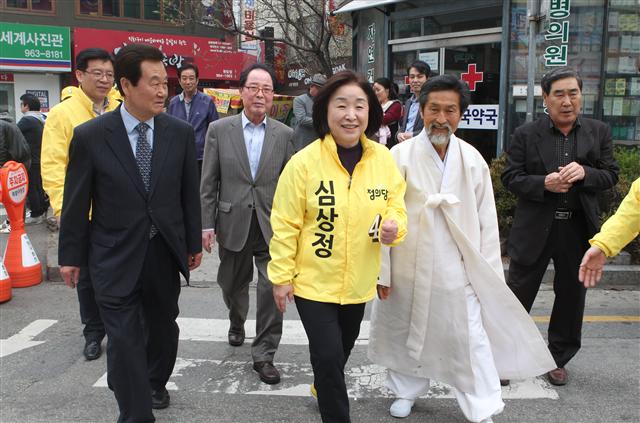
200, 64, 294, 384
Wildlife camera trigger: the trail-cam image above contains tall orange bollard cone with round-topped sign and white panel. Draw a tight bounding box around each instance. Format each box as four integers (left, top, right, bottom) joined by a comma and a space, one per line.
0, 161, 42, 288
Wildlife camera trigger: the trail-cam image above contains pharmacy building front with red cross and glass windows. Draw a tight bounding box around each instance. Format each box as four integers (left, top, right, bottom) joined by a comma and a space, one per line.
337, 0, 640, 160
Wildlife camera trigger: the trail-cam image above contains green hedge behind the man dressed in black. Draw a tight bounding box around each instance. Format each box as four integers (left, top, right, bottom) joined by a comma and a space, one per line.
490, 146, 640, 263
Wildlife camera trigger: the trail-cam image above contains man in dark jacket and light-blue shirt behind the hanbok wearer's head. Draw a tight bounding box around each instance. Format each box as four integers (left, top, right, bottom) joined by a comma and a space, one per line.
396, 60, 431, 142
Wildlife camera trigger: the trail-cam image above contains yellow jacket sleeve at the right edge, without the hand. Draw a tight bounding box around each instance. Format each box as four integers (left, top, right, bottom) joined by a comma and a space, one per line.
589, 178, 640, 257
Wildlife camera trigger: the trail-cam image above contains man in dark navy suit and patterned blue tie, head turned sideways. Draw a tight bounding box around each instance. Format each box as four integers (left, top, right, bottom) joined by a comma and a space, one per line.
59, 44, 202, 422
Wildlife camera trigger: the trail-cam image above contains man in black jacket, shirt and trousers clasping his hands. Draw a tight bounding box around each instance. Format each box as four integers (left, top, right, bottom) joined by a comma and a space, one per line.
502, 68, 618, 385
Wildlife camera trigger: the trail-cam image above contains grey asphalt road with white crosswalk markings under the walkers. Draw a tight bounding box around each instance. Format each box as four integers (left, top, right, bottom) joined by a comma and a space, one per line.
0, 274, 640, 423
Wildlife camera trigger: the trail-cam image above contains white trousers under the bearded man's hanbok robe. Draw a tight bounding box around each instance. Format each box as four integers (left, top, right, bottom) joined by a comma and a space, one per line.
387, 283, 504, 422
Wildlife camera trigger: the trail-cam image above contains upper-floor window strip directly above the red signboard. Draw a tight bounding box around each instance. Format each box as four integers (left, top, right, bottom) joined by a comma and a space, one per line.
79, 0, 183, 25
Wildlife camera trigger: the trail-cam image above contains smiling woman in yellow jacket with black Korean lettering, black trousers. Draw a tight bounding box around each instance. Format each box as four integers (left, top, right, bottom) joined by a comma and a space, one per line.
268, 71, 407, 422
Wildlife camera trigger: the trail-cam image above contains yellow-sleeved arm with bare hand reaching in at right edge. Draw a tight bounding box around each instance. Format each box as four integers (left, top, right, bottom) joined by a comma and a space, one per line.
578, 178, 640, 288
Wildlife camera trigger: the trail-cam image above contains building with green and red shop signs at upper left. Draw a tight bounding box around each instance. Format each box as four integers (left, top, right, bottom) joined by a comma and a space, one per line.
0, 0, 249, 119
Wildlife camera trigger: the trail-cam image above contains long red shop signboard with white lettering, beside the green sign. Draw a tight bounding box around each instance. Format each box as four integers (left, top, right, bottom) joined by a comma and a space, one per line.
73, 28, 256, 81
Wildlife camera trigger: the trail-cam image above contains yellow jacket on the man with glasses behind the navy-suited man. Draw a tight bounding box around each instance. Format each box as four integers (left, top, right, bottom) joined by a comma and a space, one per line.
40, 89, 120, 216
